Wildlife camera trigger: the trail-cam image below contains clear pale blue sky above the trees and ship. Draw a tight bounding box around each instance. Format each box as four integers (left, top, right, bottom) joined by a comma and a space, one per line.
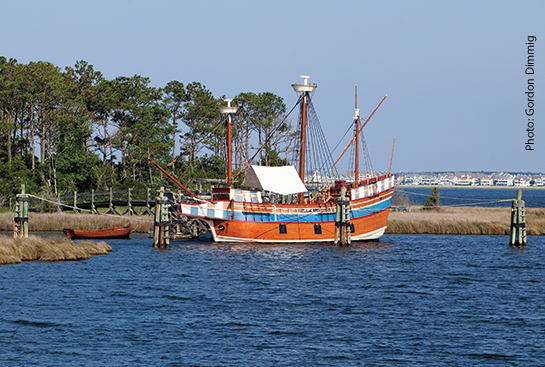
0, 0, 545, 172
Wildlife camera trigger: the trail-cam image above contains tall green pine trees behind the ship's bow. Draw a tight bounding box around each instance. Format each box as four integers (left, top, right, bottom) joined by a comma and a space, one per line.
0, 57, 297, 201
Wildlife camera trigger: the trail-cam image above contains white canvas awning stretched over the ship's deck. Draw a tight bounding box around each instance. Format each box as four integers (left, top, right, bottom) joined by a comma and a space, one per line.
242, 166, 307, 195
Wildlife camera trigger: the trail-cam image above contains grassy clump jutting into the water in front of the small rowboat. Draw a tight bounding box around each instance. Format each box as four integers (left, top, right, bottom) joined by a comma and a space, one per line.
0, 236, 112, 265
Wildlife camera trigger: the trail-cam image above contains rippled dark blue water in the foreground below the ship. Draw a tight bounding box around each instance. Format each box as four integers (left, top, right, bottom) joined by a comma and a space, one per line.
0, 234, 545, 366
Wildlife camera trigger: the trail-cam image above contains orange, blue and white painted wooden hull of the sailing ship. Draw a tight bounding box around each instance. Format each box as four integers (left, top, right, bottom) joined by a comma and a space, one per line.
179, 175, 394, 243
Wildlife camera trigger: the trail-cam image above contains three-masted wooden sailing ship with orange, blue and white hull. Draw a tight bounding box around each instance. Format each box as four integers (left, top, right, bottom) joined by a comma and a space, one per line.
152, 75, 395, 245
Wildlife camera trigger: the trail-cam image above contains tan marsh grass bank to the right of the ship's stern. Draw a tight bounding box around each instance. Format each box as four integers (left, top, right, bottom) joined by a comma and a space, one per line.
386, 207, 545, 236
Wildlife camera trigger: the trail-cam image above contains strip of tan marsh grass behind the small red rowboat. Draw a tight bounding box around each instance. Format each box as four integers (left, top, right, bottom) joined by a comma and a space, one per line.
0, 213, 153, 233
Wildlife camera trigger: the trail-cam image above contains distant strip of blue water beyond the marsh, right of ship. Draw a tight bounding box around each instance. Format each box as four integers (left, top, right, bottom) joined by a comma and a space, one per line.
396, 186, 545, 208
